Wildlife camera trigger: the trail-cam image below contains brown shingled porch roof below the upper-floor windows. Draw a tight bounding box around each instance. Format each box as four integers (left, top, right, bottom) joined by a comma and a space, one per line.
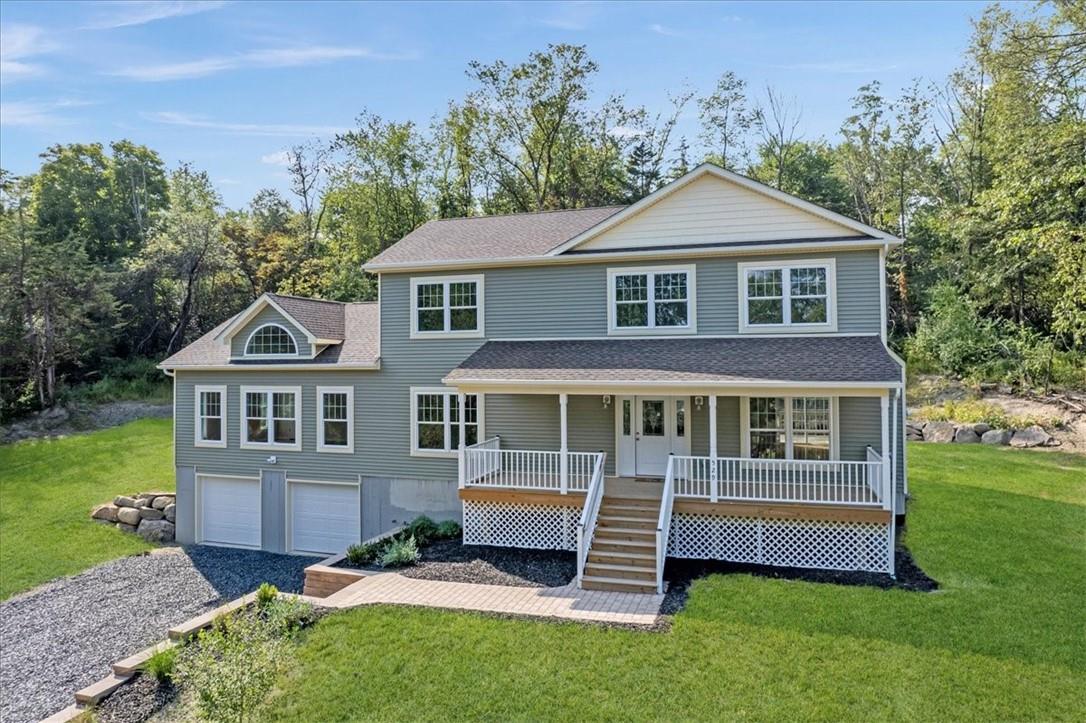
444, 335, 901, 389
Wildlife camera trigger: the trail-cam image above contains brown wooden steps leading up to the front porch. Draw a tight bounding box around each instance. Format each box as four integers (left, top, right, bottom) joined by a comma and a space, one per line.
581, 480, 661, 593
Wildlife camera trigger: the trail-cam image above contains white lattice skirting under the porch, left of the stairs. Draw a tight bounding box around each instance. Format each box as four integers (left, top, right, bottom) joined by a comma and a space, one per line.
464, 499, 581, 549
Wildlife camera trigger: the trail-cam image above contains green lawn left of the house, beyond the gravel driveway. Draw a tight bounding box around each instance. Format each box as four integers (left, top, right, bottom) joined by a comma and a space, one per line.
0, 419, 174, 599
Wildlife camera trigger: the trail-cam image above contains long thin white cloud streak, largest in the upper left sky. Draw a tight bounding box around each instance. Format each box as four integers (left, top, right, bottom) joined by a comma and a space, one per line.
111, 46, 417, 83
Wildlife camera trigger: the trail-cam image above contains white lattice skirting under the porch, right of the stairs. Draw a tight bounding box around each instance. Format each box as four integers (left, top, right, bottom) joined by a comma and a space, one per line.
668, 512, 893, 572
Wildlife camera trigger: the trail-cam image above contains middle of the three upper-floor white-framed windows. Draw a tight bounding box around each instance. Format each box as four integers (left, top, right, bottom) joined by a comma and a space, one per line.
607, 266, 697, 334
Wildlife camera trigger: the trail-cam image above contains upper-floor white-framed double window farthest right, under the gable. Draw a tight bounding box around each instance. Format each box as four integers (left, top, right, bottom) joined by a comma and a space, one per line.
738, 259, 837, 332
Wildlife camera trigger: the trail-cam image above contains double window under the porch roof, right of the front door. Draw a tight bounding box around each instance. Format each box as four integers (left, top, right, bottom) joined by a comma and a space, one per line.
743, 396, 836, 460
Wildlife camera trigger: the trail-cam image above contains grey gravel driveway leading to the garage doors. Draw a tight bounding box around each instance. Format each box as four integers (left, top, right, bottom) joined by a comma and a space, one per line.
0, 546, 317, 723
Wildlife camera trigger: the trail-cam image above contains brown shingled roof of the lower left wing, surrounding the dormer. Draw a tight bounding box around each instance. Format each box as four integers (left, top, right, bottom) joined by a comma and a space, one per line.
159, 296, 381, 369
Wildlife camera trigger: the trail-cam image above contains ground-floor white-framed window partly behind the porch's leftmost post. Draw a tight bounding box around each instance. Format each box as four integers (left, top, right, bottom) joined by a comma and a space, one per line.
411, 386, 482, 456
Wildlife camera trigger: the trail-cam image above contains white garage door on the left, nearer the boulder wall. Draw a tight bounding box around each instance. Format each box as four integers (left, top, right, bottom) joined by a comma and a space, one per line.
199, 477, 261, 548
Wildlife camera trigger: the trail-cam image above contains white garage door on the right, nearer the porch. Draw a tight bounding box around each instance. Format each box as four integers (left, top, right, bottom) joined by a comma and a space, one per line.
289, 482, 362, 555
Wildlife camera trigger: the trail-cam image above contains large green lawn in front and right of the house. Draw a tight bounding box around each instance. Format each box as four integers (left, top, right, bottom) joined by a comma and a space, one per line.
262, 445, 1086, 721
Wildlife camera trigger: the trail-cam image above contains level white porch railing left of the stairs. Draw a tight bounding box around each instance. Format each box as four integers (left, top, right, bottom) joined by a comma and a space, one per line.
460, 436, 602, 493
